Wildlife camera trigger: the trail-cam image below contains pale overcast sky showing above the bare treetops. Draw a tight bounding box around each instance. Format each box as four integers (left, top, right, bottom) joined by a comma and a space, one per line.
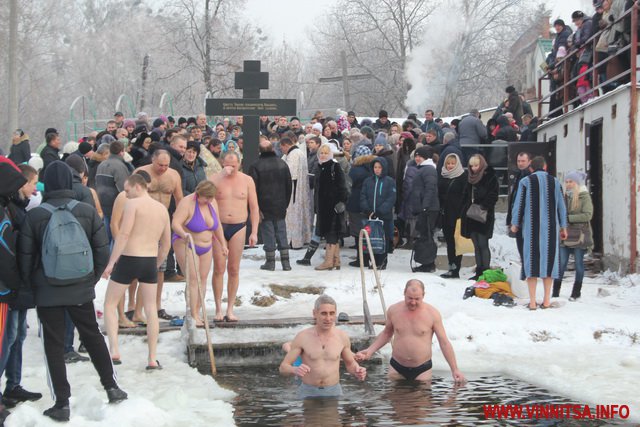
246, 0, 593, 47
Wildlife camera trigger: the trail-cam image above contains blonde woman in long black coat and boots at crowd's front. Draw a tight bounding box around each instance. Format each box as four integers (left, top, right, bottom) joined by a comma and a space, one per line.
314, 144, 349, 270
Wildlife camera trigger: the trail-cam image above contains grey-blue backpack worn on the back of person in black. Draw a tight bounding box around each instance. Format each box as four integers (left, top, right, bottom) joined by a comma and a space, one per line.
40, 200, 94, 286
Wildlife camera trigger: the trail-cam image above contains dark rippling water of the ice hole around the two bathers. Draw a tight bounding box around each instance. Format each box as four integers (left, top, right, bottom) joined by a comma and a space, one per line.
216, 365, 616, 427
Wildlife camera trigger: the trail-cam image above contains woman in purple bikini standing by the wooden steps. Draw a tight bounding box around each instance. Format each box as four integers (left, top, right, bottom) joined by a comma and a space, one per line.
171, 181, 228, 327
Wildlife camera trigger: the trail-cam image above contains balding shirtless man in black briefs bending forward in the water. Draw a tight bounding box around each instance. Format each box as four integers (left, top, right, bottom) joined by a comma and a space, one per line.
355, 279, 465, 384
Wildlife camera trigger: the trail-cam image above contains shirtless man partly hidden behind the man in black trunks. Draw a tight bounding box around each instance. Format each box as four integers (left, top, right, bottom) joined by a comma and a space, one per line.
134, 150, 182, 320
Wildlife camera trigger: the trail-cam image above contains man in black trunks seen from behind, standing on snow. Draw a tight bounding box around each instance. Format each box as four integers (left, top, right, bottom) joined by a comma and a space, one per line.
102, 174, 171, 370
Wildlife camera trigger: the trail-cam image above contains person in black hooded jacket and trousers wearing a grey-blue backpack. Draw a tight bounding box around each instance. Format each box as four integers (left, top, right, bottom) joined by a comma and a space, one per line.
18, 161, 127, 421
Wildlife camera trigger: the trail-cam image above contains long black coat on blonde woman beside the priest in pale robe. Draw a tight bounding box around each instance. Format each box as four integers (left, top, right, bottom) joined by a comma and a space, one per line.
314, 160, 349, 237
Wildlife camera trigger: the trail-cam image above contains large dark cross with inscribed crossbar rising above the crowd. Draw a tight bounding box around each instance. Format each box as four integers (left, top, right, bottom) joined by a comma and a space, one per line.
205, 61, 296, 171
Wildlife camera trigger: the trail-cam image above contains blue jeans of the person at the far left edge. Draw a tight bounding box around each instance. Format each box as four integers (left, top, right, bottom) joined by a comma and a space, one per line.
0, 309, 27, 390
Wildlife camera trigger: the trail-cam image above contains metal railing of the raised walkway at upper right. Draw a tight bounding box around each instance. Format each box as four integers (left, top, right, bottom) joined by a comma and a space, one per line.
538, 2, 638, 120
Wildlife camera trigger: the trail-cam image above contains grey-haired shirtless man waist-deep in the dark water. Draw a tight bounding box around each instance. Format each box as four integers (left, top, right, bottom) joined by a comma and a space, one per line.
280, 295, 367, 399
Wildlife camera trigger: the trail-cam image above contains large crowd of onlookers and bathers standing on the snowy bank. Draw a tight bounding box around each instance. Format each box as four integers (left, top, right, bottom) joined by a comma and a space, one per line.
0, 87, 592, 420
